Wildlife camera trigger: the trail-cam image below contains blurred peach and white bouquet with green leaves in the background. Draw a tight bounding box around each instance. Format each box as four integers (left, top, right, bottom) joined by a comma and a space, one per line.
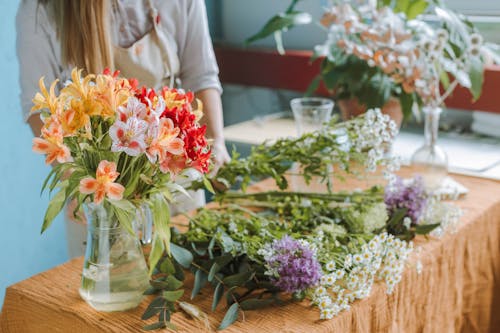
248, 0, 498, 116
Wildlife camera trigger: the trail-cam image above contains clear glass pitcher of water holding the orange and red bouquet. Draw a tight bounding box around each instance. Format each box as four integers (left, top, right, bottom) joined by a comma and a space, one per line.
80, 204, 149, 312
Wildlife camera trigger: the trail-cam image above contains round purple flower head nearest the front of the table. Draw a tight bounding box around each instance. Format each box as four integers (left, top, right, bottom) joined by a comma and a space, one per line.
266, 236, 321, 293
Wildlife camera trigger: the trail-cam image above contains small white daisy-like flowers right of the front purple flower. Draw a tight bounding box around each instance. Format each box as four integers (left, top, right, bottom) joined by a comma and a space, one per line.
311, 233, 413, 319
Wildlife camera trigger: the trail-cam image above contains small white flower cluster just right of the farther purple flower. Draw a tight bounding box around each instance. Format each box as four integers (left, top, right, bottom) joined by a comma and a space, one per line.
420, 197, 463, 237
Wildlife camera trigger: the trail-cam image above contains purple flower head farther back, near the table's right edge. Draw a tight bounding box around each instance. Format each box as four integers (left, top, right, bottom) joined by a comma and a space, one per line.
384, 176, 427, 224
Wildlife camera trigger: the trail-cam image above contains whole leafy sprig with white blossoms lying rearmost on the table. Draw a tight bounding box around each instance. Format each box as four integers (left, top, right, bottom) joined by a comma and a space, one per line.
215, 110, 396, 191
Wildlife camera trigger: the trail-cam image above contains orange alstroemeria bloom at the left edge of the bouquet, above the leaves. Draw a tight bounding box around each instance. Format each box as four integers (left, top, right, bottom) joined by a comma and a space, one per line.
33, 122, 73, 164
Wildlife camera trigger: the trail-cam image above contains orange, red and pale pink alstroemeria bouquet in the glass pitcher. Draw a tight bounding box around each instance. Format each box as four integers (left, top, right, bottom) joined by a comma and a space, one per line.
32, 68, 211, 266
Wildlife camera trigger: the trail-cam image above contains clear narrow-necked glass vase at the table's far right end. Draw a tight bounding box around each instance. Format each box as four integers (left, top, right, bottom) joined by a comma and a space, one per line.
411, 107, 448, 192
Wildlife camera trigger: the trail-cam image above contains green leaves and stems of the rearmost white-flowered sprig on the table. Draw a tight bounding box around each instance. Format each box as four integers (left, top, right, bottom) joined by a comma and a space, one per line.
215, 117, 388, 191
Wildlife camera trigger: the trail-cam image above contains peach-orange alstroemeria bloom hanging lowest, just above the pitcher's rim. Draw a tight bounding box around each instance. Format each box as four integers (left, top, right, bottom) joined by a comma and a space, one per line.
80, 160, 125, 204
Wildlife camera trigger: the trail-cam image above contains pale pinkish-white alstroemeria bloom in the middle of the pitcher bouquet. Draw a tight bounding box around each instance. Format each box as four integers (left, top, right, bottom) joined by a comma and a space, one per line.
109, 117, 148, 156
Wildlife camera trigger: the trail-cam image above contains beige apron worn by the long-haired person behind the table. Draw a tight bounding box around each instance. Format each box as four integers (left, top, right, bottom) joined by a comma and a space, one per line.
66, 1, 205, 258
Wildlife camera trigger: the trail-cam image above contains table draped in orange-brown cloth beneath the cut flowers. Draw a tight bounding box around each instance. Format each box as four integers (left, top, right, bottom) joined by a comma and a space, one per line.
0, 170, 500, 333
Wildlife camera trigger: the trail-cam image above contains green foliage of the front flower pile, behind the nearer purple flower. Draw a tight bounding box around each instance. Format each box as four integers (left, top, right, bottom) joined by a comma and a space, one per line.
144, 182, 442, 329
